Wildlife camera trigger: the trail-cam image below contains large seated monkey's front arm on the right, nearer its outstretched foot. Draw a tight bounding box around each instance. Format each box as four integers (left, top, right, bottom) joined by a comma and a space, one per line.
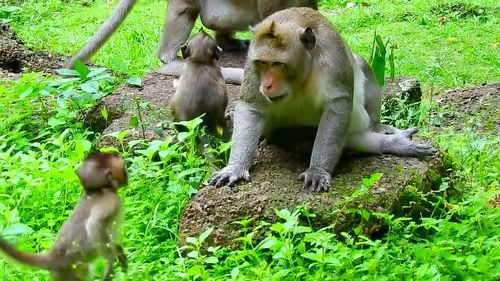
299, 94, 352, 191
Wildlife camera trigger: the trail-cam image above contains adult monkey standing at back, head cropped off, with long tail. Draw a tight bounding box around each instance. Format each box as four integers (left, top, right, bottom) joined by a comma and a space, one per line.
67, 0, 318, 67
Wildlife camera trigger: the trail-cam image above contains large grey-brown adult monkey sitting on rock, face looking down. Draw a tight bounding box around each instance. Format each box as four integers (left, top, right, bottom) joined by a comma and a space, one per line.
210, 8, 435, 191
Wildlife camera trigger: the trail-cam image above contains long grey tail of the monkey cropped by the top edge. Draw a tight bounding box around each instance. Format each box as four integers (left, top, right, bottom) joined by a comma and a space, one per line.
66, 0, 137, 68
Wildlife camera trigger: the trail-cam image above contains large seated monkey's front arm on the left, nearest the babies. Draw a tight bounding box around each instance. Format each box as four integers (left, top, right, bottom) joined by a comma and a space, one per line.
210, 102, 264, 186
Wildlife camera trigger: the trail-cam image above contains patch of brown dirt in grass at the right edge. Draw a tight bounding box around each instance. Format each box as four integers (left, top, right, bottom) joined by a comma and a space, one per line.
434, 83, 500, 132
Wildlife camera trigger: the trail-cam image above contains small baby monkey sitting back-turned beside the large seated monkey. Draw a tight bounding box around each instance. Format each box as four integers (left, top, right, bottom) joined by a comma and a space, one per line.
171, 31, 227, 132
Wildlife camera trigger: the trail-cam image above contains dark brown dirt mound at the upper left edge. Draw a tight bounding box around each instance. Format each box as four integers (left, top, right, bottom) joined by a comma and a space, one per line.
0, 22, 66, 78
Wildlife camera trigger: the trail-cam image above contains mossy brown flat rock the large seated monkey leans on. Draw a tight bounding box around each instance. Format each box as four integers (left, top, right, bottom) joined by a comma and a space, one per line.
180, 138, 444, 245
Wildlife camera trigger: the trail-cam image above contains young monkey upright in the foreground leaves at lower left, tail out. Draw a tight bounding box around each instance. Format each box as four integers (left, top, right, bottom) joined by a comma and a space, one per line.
0, 153, 128, 281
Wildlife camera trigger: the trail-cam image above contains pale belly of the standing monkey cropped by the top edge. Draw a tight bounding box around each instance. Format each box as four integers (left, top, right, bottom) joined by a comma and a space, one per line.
200, 0, 260, 30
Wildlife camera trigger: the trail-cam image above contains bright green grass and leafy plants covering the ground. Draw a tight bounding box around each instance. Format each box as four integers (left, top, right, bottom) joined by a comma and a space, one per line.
0, 0, 500, 281
